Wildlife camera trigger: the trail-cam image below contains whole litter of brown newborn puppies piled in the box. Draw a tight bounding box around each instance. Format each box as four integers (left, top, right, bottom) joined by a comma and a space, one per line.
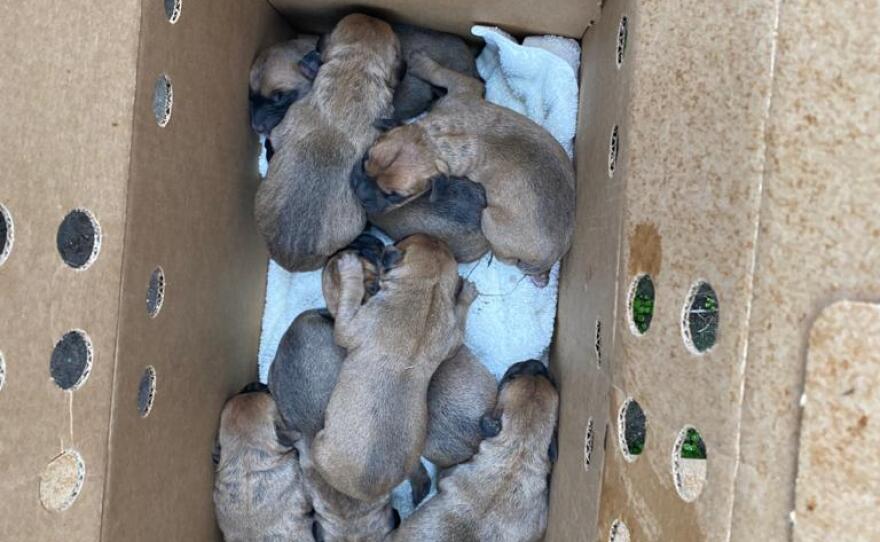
214, 14, 575, 541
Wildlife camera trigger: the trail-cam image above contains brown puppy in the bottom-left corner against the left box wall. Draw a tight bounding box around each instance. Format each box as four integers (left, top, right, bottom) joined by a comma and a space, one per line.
214, 388, 312, 542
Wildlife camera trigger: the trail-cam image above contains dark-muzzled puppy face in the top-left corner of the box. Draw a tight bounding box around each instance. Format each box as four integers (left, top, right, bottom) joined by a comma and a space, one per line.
249, 34, 321, 136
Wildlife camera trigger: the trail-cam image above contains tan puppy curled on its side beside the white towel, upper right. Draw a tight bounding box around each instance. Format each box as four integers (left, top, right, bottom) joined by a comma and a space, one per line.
352, 54, 574, 285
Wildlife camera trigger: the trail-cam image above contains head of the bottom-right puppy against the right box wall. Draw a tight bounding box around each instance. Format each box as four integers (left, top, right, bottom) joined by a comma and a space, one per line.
480, 360, 559, 460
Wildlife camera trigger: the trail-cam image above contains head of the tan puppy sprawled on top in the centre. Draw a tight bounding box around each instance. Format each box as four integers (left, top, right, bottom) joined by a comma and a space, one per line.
382, 233, 461, 289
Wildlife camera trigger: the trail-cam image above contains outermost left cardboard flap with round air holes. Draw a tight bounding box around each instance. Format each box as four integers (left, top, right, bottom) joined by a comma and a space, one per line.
0, 0, 140, 541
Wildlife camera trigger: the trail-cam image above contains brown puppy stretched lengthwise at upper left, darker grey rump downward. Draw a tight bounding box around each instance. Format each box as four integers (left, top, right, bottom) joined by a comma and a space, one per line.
255, 14, 400, 271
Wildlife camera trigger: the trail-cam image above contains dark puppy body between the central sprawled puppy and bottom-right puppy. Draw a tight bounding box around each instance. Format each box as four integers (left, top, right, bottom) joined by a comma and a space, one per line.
422, 346, 498, 469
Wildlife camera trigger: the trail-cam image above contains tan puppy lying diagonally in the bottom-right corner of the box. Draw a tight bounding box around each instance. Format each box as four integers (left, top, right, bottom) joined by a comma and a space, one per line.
391, 360, 559, 542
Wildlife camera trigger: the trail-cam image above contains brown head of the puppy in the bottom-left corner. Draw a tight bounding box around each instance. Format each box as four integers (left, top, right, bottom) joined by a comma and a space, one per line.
214, 385, 296, 463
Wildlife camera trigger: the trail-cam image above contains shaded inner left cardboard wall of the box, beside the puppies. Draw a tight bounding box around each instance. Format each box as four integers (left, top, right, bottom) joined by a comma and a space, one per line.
102, 0, 287, 541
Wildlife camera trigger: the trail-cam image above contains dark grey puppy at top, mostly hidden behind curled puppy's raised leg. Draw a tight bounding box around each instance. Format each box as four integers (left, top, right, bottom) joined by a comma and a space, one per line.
394, 24, 477, 120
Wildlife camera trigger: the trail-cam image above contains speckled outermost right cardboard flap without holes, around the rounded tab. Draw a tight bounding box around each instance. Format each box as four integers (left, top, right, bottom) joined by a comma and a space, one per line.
732, 1, 880, 541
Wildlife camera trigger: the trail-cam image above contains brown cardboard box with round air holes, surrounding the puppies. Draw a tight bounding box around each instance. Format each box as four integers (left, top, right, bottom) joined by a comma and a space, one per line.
0, 0, 880, 542
